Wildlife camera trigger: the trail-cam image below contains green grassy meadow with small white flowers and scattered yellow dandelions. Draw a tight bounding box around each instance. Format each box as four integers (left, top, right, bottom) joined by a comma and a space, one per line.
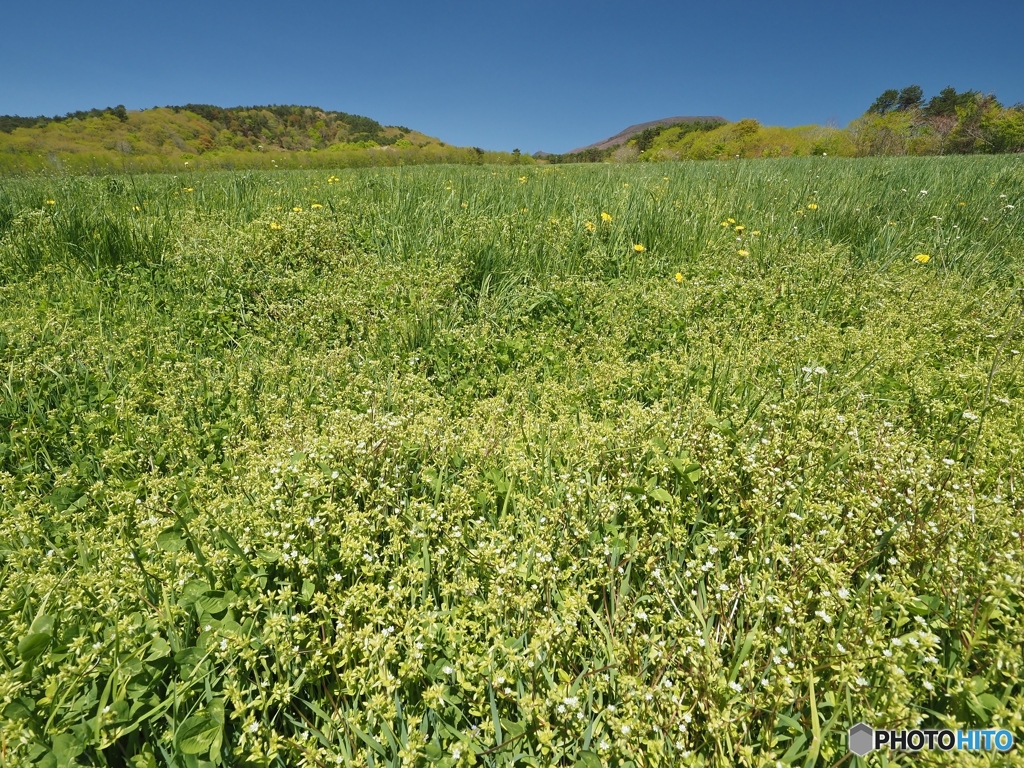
0, 157, 1024, 768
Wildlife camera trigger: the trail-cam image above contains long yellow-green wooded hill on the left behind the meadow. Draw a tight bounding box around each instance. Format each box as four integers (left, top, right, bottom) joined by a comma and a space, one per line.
0, 104, 530, 173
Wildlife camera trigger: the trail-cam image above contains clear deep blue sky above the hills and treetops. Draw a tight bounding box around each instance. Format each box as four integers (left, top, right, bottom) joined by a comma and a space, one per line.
0, 0, 1024, 153
